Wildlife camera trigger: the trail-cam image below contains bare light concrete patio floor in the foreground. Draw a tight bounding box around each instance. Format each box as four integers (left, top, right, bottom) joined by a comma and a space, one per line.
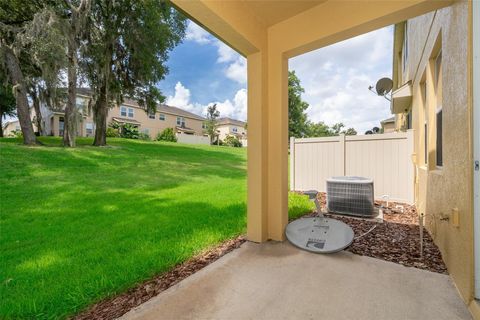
122, 242, 471, 320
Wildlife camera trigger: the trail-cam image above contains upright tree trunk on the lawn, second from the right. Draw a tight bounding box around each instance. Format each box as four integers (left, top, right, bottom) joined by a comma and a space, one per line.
63, 31, 78, 147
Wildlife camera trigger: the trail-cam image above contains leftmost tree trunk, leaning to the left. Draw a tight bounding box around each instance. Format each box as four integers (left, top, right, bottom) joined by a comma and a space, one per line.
3, 45, 37, 145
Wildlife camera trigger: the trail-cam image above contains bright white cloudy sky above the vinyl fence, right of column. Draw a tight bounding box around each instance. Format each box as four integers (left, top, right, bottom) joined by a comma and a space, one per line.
290, 27, 392, 134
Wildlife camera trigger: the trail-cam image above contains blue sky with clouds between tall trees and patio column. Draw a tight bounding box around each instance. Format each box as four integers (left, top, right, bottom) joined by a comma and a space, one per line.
159, 22, 247, 120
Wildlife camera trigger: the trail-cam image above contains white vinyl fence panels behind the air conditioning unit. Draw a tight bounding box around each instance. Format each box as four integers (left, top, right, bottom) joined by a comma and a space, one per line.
290, 130, 414, 203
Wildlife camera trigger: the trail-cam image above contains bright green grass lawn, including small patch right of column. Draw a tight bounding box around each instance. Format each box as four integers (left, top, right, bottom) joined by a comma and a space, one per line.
0, 137, 312, 318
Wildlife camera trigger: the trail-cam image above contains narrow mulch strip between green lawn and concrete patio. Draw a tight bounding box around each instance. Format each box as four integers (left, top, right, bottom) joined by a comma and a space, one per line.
74, 236, 246, 320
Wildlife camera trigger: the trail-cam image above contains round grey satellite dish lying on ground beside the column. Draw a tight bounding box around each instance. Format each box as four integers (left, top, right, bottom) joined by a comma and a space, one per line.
285, 217, 354, 253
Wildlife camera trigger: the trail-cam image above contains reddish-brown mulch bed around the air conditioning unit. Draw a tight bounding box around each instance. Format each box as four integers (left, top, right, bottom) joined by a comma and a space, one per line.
307, 193, 447, 274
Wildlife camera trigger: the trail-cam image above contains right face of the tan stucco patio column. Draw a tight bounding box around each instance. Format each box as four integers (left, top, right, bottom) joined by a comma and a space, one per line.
267, 49, 288, 241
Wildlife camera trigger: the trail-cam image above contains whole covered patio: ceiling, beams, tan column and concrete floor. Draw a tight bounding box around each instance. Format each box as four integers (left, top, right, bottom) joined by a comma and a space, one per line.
116, 0, 471, 319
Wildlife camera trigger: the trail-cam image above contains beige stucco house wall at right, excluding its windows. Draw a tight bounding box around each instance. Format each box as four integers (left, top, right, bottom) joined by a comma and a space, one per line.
398, 2, 473, 303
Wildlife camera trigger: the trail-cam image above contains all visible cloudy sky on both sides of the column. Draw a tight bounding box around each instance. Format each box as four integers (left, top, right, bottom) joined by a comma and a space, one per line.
159, 22, 393, 133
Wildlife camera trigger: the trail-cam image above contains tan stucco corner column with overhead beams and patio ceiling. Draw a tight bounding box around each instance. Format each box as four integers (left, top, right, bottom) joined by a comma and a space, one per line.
173, 0, 452, 242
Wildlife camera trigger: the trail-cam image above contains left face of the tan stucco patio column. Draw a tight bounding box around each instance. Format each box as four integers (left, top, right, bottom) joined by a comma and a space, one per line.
247, 52, 268, 242
